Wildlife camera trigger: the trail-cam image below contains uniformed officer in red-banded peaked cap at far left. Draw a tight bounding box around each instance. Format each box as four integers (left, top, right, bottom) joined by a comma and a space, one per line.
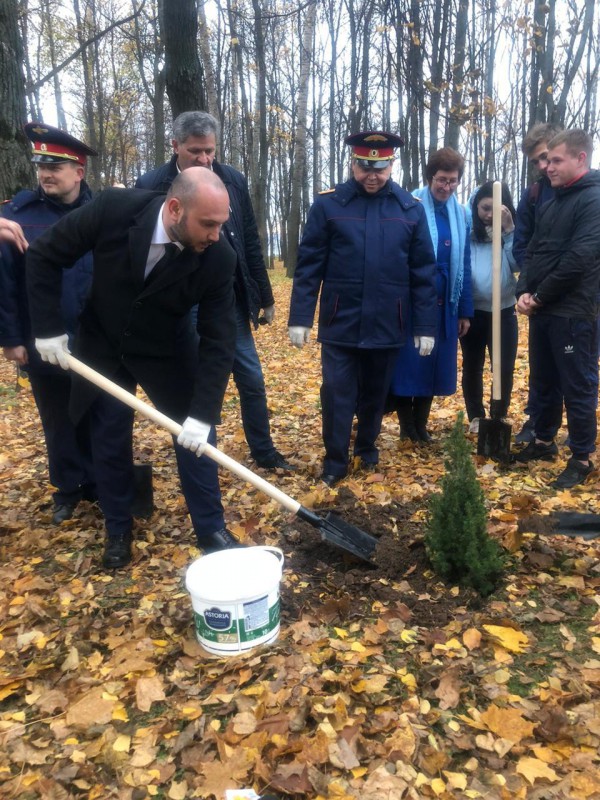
0, 122, 97, 524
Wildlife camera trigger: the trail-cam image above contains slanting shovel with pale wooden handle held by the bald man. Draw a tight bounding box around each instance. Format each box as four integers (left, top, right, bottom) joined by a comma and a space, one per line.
67, 355, 377, 563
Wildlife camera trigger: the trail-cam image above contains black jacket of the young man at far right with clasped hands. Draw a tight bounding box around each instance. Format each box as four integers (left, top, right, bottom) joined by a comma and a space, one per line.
516, 170, 600, 319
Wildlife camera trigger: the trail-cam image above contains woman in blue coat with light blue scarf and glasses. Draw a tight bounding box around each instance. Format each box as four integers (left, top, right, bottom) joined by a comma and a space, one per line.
391, 147, 473, 443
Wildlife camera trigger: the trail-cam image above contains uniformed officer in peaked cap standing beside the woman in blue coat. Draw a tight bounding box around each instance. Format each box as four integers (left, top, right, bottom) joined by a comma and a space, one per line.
288, 131, 437, 486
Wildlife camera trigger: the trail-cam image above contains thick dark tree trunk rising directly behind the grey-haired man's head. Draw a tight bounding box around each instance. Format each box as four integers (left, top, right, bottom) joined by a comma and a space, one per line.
161, 0, 207, 118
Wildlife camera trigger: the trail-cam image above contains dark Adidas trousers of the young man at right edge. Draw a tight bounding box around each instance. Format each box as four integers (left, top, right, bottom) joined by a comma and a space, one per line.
529, 314, 598, 460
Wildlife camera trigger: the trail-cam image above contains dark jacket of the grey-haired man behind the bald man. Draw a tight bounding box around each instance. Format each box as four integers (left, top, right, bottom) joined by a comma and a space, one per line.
135, 154, 275, 325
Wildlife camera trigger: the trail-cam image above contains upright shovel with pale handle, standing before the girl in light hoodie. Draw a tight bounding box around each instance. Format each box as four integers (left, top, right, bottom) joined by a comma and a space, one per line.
474, 181, 511, 464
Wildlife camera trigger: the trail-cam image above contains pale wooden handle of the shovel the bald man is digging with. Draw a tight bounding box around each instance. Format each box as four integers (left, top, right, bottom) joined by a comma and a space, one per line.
67, 354, 301, 514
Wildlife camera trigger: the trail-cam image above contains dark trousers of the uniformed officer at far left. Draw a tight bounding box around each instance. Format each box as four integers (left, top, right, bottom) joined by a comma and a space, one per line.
28, 367, 96, 506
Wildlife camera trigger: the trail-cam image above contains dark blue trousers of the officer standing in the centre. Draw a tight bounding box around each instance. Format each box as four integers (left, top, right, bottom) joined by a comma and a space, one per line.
321, 344, 398, 476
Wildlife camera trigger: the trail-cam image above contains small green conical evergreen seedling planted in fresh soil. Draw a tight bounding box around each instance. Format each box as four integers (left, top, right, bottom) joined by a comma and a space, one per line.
425, 413, 504, 595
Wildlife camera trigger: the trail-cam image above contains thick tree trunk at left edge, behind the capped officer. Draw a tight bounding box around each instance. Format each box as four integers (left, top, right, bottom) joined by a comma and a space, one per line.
0, 0, 35, 200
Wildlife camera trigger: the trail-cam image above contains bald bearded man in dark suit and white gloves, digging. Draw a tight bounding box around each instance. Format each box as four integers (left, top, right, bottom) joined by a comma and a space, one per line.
27, 168, 238, 568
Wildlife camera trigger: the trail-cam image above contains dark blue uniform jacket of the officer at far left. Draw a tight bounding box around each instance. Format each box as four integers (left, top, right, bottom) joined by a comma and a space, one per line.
0, 182, 92, 372
